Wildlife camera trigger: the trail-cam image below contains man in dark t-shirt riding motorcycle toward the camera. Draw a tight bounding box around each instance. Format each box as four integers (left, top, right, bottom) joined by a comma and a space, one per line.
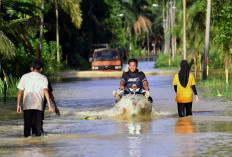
113, 59, 152, 103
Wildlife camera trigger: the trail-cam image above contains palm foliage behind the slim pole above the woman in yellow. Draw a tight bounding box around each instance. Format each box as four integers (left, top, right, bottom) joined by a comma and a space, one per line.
169, 1, 205, 70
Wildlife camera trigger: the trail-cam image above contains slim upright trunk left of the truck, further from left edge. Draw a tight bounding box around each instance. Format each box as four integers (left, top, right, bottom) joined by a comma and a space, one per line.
55, 0, 60, 63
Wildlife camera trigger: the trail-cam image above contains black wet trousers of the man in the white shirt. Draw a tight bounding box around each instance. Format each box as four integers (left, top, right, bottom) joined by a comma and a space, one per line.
23, 110, 42, 137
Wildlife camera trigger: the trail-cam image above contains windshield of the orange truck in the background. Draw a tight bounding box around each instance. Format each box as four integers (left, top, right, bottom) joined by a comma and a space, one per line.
94, 51, 120, 61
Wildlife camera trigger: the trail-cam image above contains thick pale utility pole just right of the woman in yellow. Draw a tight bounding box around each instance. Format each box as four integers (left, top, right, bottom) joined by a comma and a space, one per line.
203, 0, 211, 79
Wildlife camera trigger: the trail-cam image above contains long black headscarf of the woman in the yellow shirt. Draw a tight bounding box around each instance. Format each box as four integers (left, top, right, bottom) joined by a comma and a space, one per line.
178, 60, 189, 87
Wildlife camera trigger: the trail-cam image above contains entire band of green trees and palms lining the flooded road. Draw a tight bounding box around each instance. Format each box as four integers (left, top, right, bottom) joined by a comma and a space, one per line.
0, 0, 232, 98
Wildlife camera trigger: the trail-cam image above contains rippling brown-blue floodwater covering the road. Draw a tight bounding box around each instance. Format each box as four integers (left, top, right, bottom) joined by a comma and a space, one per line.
0, 62, 232, 157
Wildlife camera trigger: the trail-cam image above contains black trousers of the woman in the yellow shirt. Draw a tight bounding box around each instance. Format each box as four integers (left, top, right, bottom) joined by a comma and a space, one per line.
177, 102, 192, 117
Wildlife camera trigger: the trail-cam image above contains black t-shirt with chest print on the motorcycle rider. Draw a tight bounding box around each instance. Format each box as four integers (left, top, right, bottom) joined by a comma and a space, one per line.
121, 70, 147, 88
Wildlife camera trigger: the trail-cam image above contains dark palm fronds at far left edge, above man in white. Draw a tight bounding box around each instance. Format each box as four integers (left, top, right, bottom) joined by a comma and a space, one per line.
0, 0, 38, 98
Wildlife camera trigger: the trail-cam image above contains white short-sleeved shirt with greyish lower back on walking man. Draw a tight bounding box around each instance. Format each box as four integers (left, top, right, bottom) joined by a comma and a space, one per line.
17, 72, 48, 111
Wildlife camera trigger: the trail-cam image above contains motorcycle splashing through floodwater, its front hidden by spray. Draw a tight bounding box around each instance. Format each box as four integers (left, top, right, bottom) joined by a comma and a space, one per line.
115, 84, 152, 117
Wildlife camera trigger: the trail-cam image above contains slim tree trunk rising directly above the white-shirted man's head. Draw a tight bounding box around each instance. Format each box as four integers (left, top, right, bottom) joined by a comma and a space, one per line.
39, 0, 44, 59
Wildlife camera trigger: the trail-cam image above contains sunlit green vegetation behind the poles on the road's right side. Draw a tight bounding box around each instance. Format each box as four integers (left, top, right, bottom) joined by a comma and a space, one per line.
156, 0, 232, 71
